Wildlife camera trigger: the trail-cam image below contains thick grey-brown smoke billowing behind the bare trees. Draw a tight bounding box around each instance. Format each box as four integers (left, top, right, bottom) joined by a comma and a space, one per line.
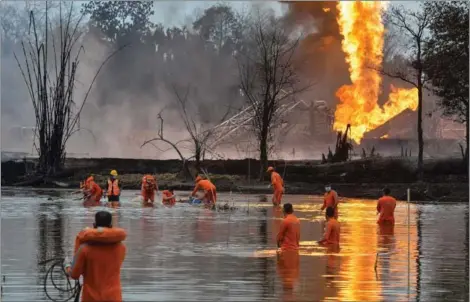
1, 2, 454, 162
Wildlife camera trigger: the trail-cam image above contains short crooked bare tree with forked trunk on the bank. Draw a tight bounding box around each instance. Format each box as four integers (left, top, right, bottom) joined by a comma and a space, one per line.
141, 85, 230, 176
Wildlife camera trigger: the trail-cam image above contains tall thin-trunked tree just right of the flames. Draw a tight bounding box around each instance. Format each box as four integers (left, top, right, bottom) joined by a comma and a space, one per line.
381, 6, 430, 179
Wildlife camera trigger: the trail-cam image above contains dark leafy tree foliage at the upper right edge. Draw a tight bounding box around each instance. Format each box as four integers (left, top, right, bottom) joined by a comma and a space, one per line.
424, 1, 469, 166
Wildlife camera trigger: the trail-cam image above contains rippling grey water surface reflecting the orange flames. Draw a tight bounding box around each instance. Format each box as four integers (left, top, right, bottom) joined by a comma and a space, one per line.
1, 189, 469, 301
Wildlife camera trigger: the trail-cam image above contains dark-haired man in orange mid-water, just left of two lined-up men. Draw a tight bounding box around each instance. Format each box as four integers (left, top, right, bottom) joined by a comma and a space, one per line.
277, 203, 300, 253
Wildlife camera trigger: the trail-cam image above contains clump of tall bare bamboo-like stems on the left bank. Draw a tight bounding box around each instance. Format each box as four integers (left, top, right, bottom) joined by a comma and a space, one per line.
15, 2, 126, 175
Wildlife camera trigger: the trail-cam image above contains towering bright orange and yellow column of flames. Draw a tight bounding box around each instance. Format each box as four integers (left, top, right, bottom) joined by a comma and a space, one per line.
333, 1, 418, 143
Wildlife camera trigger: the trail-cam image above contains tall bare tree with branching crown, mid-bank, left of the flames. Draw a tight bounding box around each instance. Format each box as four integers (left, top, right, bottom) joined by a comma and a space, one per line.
237, 11, 308, 179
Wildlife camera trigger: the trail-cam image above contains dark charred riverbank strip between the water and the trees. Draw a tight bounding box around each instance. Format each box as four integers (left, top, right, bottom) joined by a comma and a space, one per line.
2, 158, 469, 202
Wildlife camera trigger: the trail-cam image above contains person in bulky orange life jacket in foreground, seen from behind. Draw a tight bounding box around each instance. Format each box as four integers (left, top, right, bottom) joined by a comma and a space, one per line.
65, 211, 126, 302
